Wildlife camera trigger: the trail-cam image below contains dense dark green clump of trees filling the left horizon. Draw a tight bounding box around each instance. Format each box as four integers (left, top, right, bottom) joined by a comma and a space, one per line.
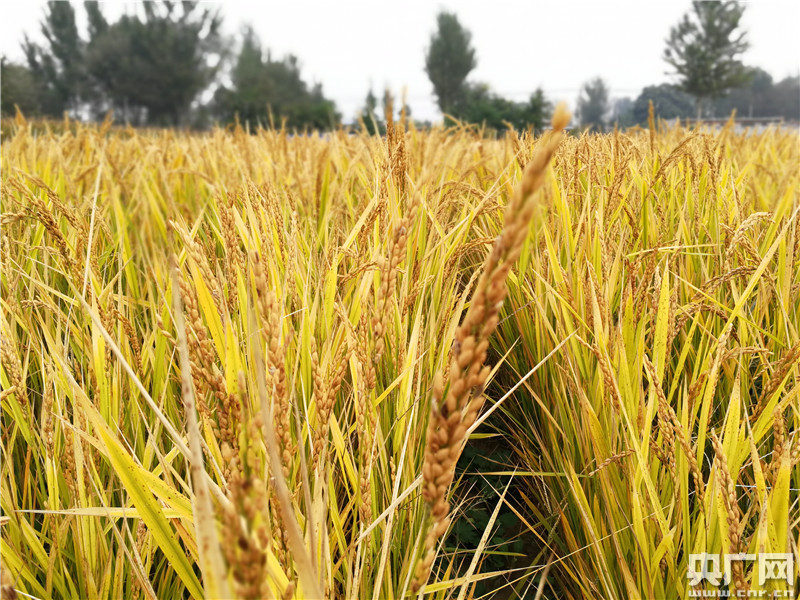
0, 0, 340, 129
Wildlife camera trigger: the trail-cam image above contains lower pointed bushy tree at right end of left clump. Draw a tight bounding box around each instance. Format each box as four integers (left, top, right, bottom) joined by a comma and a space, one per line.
214, 28, 339, 129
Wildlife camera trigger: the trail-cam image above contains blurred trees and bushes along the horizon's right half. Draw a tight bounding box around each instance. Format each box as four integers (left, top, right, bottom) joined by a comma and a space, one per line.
425, 1, 800, 131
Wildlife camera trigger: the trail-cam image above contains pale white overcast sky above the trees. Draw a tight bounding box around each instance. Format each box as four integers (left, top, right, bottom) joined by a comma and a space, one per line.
0, 0, 800, 121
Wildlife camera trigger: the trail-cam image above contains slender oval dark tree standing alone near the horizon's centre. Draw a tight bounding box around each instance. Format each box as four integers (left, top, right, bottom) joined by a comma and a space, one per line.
425, 12, 477, 114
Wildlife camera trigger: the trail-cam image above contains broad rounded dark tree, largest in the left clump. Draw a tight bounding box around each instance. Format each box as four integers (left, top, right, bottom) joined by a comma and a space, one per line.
87, 1, 222, 126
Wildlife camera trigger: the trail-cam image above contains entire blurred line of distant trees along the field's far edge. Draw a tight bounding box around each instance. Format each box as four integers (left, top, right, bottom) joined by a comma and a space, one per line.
0, 0, 800, 133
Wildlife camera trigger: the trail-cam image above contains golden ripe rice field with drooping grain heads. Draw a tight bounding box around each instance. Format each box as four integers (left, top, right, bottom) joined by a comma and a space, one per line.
0, 109, 800, 600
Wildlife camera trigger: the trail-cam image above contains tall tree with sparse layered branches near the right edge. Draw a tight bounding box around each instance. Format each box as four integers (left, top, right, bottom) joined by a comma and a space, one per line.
664, 1, 750, 120
